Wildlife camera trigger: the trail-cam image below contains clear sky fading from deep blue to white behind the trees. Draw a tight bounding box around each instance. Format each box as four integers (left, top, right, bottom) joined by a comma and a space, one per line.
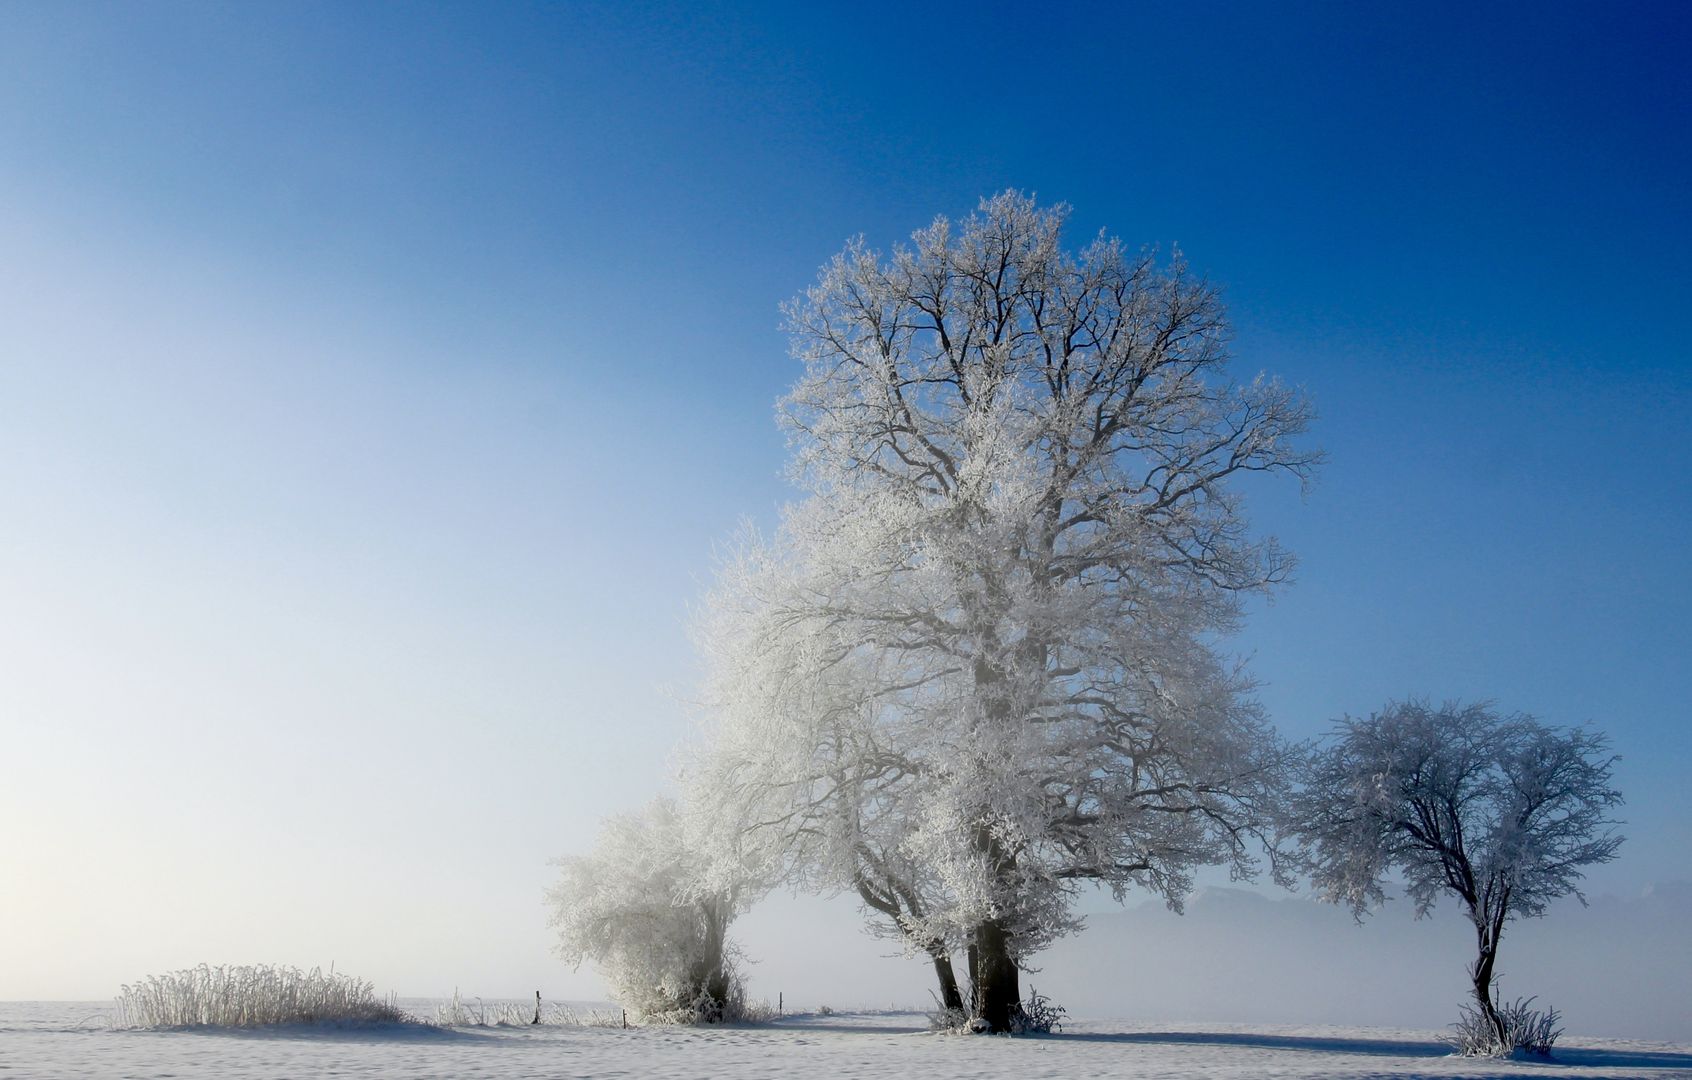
0, 2, 1692, 999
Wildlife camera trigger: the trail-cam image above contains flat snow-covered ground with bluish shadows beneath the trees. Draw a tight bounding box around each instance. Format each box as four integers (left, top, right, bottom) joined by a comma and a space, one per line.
0, 1002, 1692, 1080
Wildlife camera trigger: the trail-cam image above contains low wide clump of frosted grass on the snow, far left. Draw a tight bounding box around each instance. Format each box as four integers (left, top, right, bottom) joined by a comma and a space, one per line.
117, 963, 415, 1028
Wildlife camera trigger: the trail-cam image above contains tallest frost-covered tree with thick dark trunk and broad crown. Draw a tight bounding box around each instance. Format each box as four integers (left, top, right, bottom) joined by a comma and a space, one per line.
699, 193, 1316, 1031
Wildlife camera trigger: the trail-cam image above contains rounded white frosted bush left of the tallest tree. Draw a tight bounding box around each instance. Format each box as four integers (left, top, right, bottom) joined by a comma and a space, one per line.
547, 799, 744, 1022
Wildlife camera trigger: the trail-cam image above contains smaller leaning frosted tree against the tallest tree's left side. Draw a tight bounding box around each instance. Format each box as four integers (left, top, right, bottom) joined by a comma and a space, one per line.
692, 602, 964, 1011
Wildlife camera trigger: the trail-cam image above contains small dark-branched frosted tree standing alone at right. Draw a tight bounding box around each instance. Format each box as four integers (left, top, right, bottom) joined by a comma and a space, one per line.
1294, 701, 1623, 1053
